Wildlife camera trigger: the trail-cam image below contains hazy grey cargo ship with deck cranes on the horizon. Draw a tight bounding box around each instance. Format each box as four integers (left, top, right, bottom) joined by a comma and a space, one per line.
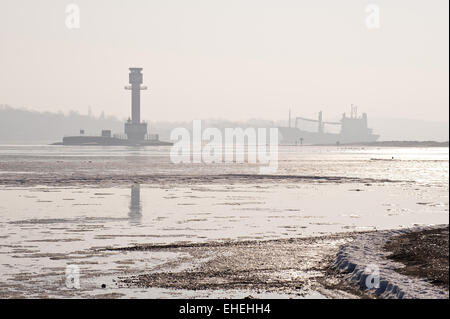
278, 105, 379, 145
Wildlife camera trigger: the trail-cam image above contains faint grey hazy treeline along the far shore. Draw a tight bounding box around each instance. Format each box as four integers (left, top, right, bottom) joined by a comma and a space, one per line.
0, 104, 449, 146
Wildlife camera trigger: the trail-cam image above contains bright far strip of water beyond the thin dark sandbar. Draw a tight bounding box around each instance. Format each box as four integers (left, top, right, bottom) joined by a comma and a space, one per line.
0, 145, 449, 182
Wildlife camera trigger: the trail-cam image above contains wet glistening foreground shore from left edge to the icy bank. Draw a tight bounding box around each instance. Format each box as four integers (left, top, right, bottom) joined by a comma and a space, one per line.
0, 233, 369, 298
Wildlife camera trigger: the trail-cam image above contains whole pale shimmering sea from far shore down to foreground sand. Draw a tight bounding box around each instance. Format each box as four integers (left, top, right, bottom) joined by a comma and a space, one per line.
0, 145, 449, 297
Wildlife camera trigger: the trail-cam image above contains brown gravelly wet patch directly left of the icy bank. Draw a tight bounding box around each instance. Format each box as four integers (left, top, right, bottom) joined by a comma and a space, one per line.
113, 234, 358, 297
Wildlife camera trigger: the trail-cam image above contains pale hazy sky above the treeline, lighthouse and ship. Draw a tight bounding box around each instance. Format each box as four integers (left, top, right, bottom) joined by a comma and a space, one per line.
0, 0, 449, 121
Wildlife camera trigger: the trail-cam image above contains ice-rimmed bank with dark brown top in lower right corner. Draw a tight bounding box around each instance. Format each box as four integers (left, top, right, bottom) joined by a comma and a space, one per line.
332, 225, 449, 299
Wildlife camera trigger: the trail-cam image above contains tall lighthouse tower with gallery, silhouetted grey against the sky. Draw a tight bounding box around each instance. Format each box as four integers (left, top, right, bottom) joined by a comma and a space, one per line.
125, 68, 147, 142
